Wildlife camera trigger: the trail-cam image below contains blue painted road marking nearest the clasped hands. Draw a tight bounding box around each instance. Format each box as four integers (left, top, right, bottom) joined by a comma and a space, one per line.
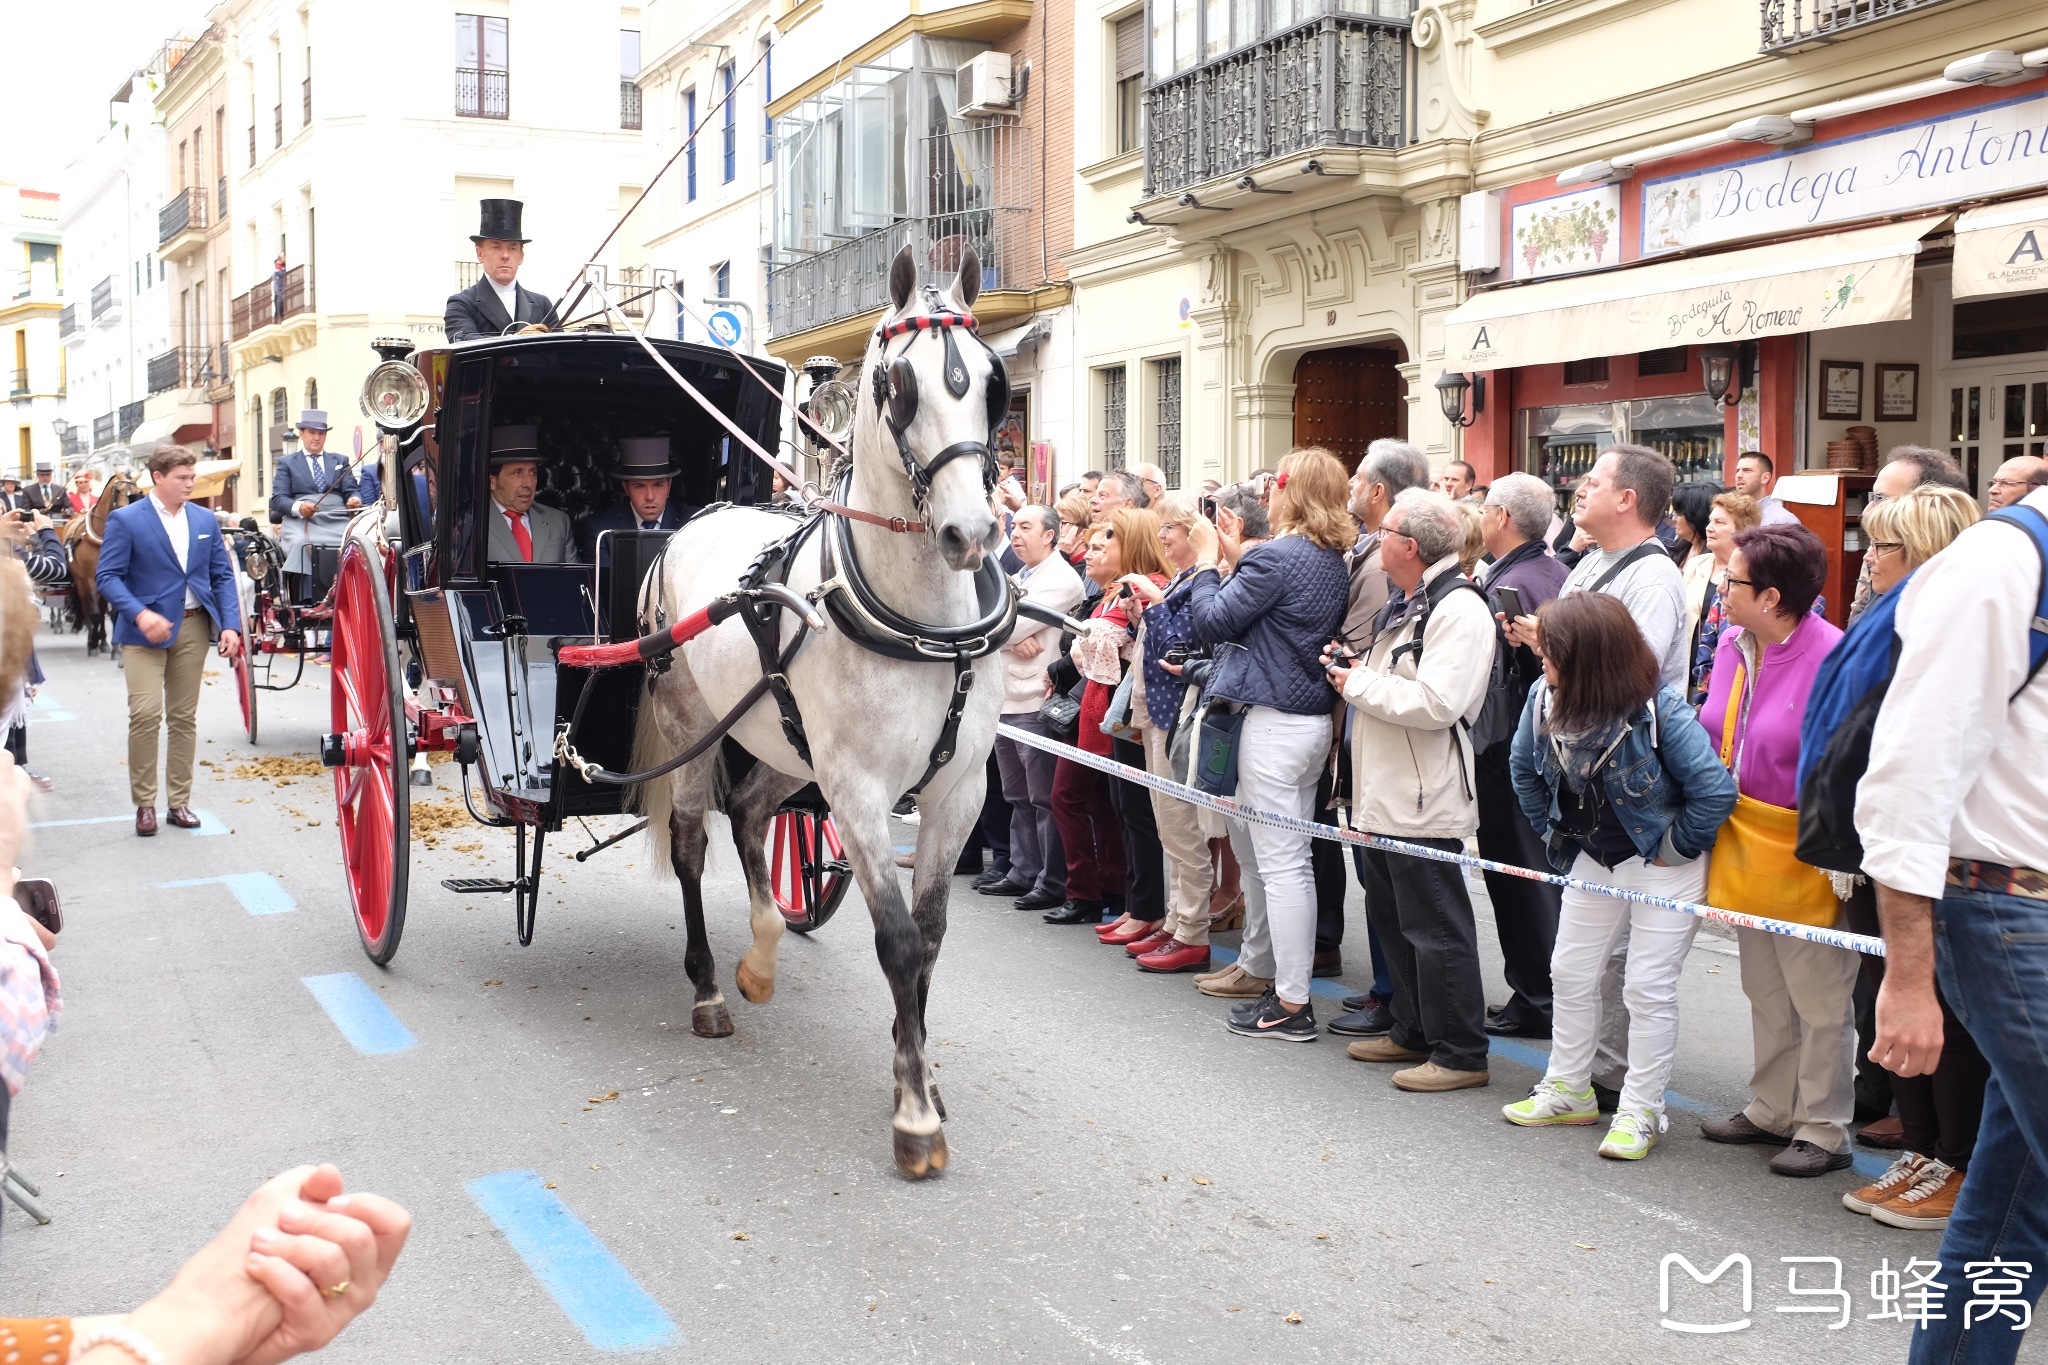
469, 1171, 678, 1351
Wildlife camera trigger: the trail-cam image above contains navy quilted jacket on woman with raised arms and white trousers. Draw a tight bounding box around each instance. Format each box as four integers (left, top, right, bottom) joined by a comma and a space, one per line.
1188, 536, 1350, 716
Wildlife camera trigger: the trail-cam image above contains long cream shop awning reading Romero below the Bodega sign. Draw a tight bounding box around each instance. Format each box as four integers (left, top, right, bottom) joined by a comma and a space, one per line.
1444, 215, 1946, 370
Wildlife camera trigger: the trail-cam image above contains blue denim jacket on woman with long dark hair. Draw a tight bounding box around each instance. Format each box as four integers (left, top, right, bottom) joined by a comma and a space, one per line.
1507, 681, 1735, 872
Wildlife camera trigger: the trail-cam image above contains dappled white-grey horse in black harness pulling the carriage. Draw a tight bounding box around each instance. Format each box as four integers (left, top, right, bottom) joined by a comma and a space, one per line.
633, 248, 1008, 1179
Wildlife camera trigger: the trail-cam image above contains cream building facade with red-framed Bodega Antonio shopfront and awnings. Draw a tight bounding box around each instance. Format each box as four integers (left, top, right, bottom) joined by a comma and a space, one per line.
1444, 0, 2048, 618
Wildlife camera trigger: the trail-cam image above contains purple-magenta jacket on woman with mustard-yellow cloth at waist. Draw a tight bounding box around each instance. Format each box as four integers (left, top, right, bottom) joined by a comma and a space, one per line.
1700, 614, 1841, 806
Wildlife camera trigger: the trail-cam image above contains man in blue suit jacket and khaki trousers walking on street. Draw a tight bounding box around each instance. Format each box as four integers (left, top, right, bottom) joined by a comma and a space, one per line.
94, 446, 242, 837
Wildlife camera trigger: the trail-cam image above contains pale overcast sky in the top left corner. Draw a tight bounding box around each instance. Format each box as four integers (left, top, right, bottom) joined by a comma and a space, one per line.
0, 0, 209, 190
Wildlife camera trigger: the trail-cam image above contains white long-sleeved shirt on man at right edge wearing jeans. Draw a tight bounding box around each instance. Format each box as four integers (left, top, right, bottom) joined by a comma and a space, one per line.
1855, 489, 2048, 898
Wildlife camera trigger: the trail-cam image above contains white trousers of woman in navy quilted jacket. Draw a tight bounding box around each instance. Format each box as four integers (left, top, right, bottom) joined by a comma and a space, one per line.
1229, 706, 1329, 1005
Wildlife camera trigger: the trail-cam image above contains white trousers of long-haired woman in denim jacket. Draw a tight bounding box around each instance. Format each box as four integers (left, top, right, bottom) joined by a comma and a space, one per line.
1548, 853, 1706, 1113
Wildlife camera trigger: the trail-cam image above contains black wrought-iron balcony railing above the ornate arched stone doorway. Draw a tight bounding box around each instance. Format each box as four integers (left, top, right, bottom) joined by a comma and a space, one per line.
1145, 14, 1409, 196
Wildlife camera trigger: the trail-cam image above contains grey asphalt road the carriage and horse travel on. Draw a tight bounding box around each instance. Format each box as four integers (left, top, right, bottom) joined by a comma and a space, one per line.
0, 636, 2048, 1365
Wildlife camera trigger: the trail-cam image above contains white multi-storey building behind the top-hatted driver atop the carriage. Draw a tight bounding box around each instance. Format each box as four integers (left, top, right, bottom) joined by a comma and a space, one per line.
211, 0, 641, 507
